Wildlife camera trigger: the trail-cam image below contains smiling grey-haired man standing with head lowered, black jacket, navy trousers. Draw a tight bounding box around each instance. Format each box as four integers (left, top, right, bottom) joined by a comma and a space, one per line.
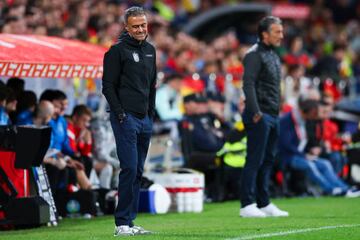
103, 7, 156, 236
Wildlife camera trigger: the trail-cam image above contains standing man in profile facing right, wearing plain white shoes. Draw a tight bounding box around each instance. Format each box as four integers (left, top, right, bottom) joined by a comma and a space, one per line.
240, 16, 289, 217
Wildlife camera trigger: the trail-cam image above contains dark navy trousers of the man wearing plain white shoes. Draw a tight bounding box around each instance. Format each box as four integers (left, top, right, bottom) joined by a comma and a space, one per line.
240, 111, 279, 208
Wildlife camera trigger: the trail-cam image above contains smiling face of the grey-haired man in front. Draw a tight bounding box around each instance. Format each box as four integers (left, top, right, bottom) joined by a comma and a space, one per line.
125, 15, 147, 41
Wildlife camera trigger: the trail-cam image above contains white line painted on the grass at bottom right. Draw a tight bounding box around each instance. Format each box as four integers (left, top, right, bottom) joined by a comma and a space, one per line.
225, 224, 360, 240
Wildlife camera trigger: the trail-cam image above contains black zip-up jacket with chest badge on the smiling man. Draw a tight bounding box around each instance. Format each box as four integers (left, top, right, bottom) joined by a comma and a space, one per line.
102, 32, 156, 118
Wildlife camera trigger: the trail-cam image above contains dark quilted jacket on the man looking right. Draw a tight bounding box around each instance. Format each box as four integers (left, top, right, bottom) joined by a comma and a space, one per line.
244, 42, 281, 116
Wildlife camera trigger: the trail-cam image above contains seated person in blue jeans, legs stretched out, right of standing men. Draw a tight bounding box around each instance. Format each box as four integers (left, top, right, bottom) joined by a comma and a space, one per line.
279, 100, 360, 197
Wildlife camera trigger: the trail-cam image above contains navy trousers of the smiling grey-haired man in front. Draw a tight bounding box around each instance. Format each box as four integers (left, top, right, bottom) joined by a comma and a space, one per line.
110, 112, 152, 227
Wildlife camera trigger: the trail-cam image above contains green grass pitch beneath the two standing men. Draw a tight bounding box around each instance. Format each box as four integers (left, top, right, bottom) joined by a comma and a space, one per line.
0, 197, 360, 240
